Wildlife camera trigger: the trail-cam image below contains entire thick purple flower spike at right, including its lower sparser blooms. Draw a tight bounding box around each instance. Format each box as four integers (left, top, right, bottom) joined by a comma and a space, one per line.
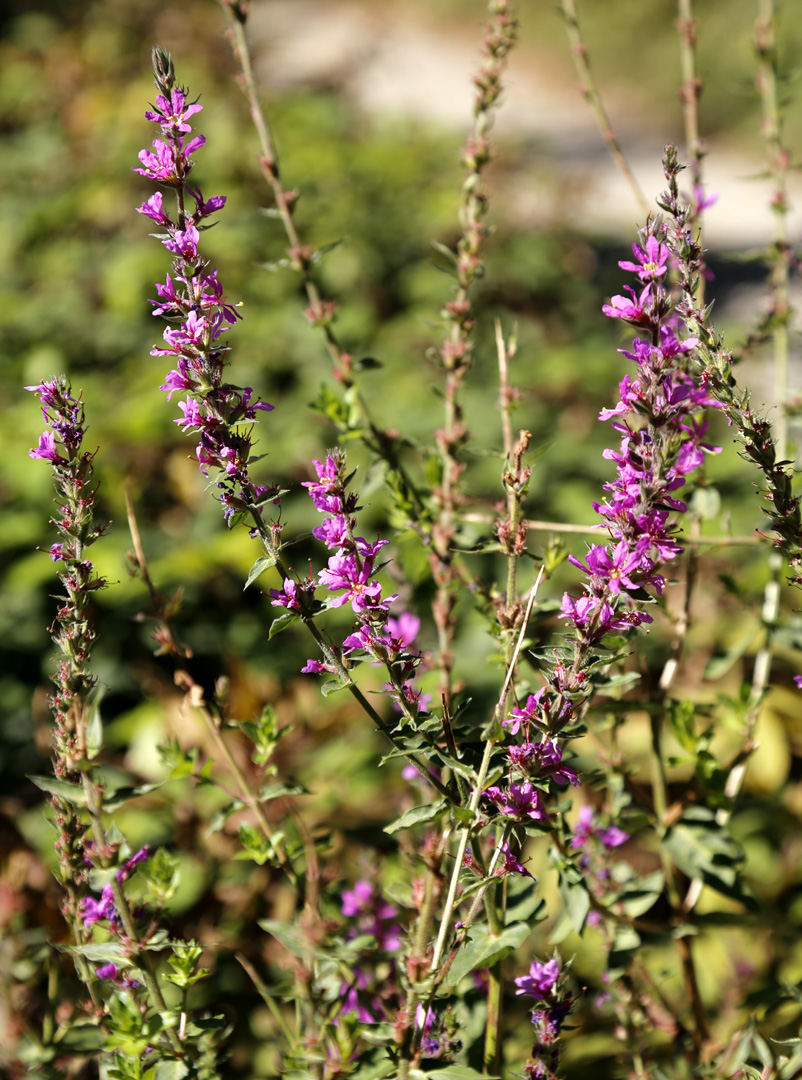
485, 219, 721, 807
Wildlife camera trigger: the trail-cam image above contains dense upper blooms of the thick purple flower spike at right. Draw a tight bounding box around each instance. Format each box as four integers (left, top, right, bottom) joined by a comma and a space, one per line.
562, 212, 721, 645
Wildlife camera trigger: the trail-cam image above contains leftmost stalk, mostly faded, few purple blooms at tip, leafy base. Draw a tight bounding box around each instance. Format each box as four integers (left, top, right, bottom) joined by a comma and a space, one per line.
27, 377, 214, 1080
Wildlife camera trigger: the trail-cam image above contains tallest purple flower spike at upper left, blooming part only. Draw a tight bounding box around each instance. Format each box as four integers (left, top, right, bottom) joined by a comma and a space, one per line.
134, 50, 277, 522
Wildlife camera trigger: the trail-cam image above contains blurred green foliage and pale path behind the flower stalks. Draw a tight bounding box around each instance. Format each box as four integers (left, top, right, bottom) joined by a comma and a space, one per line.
0, 0, 802, 1077
